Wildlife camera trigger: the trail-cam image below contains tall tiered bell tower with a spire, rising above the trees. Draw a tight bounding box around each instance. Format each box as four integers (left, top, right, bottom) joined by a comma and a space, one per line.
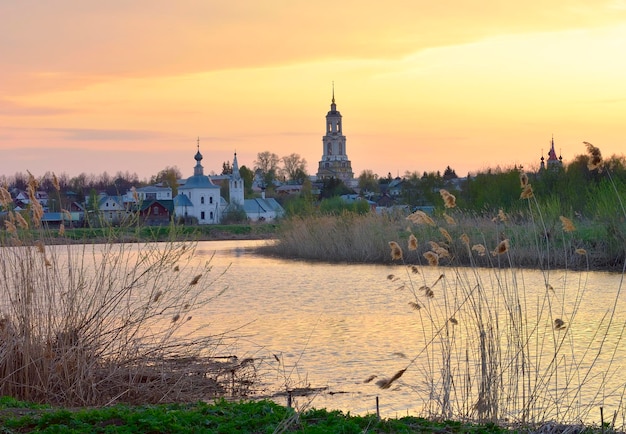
317, 85, 354, 184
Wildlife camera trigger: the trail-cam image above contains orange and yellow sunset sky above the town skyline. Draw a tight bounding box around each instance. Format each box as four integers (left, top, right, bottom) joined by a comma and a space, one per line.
0, 0, 626, 179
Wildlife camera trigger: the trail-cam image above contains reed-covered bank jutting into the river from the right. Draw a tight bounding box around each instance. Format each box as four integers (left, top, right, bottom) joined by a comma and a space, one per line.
258, 213, 626, 272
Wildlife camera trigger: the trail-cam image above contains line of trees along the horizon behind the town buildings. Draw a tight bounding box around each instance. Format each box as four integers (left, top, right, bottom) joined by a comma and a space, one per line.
0, 151, 626, 222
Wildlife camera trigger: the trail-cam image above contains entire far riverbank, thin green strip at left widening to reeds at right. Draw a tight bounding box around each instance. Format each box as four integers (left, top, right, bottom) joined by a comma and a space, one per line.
8, 213, 626, 272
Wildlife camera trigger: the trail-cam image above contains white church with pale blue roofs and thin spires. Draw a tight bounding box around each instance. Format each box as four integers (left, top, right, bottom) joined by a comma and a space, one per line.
174, 140, 285, 225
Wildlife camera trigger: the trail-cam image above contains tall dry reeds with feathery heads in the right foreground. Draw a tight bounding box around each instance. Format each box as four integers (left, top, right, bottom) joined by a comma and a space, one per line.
378, 144, 626, 424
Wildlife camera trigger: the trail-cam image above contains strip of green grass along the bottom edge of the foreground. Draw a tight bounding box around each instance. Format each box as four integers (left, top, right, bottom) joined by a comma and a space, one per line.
0, 399, 507, 434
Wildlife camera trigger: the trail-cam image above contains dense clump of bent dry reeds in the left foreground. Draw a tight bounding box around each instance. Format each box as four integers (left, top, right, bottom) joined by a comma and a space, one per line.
0, 177, 255, 406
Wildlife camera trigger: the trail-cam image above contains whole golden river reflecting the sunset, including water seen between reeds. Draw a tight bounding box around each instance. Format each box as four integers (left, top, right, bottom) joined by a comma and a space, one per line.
0, 237, 626, 426
